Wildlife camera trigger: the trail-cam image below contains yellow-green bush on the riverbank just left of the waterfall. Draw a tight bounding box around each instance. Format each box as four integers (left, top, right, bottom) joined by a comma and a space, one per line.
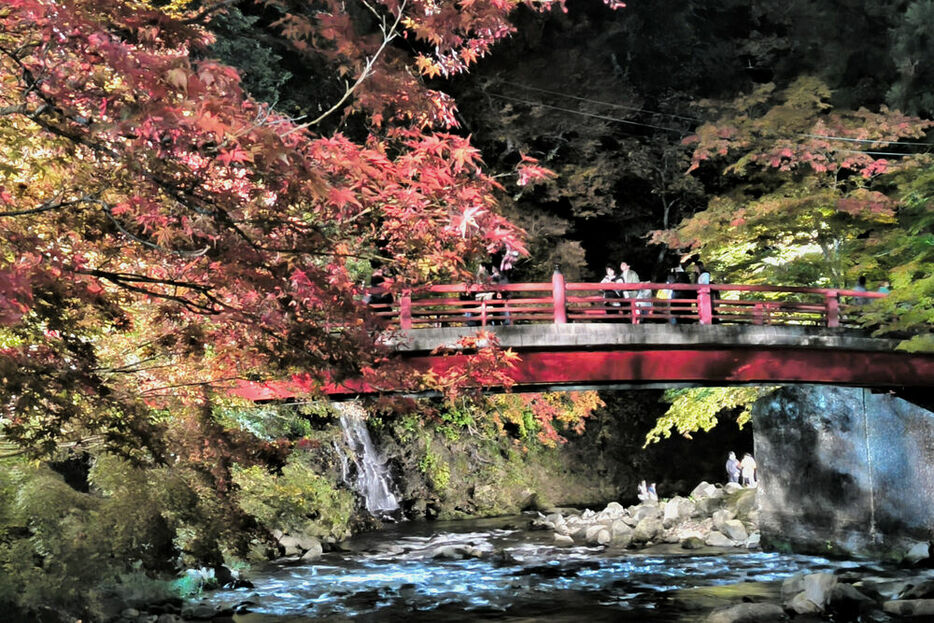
233, 453, 354, 536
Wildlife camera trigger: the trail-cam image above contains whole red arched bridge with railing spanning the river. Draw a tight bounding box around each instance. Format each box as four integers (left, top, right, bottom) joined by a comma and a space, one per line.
238, 272, 934, 400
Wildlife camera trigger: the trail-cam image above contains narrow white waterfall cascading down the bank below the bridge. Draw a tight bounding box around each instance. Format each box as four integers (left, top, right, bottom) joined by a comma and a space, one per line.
334, 402, 399, 518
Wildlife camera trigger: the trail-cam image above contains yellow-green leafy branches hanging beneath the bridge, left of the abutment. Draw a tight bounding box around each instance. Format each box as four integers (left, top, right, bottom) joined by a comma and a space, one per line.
643, 386, 777, 447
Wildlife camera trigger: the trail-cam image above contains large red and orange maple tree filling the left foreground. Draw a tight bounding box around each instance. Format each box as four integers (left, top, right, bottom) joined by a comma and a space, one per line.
0, 0, 584, 450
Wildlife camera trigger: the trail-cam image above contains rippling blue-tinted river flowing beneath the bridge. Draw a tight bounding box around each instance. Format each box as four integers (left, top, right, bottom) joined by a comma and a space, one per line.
199, 517, 872, 623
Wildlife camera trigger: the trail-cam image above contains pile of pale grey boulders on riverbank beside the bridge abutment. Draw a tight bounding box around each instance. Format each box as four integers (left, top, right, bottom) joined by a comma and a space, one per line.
532, 482, 759, 549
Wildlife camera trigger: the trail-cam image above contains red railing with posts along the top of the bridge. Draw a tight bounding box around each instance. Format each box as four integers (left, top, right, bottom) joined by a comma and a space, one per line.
370, 273, 885, 329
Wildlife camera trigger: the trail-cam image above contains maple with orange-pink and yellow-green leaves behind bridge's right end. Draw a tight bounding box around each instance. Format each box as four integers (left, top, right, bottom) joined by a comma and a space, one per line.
654, 77, 932, 287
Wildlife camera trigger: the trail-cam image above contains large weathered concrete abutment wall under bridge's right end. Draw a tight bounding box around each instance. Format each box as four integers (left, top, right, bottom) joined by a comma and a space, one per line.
753, 385, 934, 556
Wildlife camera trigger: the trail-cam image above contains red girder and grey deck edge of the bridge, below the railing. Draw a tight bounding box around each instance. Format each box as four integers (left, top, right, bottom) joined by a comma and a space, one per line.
237, 324, 934, 400
